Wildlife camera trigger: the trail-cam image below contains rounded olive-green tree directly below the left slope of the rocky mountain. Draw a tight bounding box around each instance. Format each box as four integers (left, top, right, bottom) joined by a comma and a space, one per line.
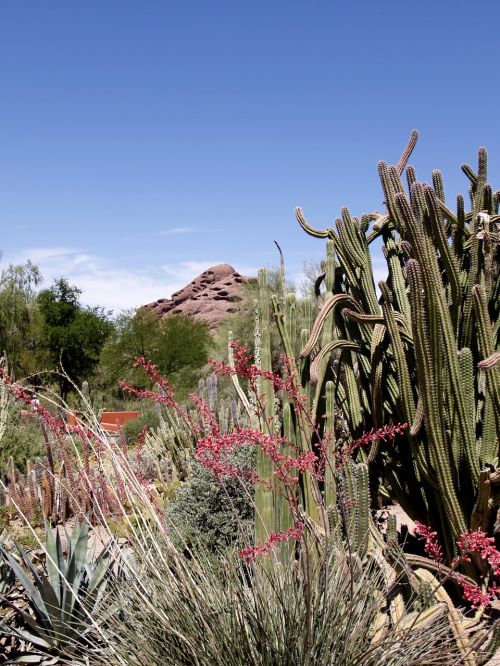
101, 309, 212, 394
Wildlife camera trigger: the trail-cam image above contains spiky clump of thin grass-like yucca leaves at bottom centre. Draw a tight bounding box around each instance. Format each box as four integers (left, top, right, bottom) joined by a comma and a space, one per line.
76, 520, 460, 666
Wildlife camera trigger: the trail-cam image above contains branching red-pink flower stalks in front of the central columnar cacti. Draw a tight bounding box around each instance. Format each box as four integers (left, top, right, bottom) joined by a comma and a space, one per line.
121, 341, 406, 561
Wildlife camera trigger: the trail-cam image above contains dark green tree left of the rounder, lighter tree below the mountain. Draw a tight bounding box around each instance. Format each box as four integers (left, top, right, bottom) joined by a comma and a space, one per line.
37, 278, 113, 400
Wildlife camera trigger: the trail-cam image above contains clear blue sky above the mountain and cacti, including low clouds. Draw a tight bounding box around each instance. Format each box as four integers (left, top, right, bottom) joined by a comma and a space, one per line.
0, 0, 500, 311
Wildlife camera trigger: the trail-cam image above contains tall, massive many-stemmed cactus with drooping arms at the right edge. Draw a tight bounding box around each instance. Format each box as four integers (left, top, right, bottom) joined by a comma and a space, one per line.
297, 132, 500, 577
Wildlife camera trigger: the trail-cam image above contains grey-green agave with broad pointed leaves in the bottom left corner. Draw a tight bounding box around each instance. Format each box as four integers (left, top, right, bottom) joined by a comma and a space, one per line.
0, 522, 113, 663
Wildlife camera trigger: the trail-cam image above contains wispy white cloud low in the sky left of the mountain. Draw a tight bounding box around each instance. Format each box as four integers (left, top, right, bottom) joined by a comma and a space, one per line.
0, 247, 256, 314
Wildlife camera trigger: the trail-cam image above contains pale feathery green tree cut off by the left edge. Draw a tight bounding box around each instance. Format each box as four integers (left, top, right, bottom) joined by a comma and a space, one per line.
0, 261, 42, 376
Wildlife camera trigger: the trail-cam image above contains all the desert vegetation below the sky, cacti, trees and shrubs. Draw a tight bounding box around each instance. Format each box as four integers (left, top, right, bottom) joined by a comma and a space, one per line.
0, 132, 500, 666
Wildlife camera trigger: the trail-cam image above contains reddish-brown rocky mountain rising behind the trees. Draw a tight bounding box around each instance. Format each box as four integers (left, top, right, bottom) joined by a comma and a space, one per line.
144, 264, 255, 329
